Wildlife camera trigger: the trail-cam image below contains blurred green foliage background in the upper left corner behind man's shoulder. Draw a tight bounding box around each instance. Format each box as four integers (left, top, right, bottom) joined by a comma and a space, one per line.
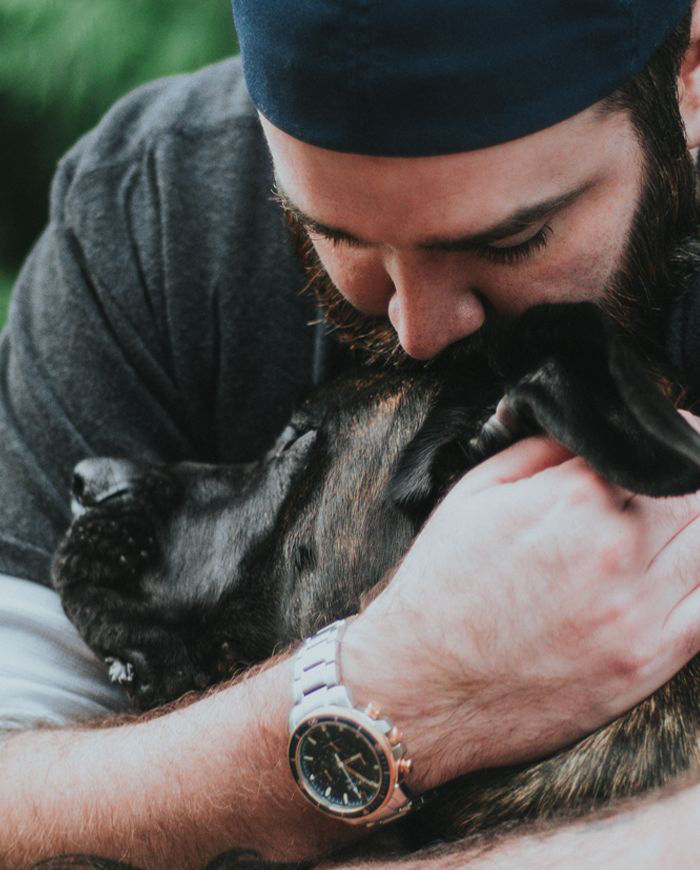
0, 0, 238, 325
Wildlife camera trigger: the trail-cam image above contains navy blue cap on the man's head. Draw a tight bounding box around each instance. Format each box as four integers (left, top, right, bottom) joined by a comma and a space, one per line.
233, 0, 690, 157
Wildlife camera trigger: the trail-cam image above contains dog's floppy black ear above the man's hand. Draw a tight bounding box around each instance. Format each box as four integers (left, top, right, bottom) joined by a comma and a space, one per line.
504, 303, 700, 496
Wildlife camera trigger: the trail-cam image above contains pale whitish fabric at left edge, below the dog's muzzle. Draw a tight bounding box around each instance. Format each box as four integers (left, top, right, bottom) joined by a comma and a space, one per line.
0, 574, 128, 738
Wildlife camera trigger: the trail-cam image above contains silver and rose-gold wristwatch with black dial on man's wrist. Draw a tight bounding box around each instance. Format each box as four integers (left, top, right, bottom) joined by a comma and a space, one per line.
289, 620, 419, 826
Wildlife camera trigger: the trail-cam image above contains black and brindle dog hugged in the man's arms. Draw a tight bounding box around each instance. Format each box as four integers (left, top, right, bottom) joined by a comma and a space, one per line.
53, 303, 700, 864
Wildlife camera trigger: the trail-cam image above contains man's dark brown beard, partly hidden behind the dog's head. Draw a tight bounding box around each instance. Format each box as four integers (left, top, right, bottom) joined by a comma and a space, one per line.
287, 116, 698, 377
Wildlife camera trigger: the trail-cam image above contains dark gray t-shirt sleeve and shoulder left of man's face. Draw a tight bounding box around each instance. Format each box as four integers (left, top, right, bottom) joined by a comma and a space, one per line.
0, 59, 342, 585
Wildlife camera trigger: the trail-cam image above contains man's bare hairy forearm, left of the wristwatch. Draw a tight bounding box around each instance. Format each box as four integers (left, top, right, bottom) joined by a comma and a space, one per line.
0, 660, 358, 870
